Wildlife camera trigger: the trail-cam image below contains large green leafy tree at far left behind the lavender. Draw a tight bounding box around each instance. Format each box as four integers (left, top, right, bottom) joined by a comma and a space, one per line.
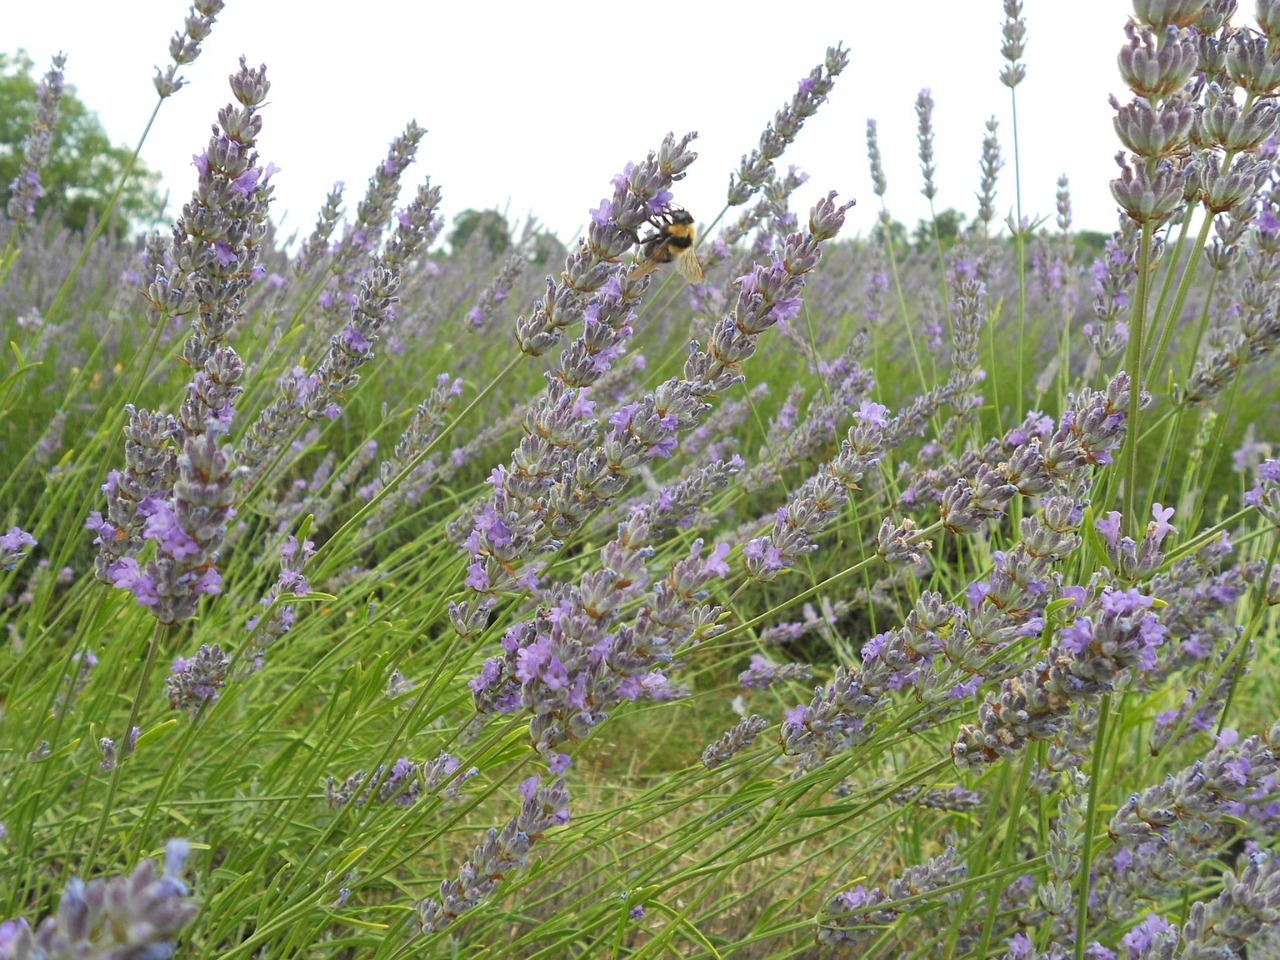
0, 50, 164, 236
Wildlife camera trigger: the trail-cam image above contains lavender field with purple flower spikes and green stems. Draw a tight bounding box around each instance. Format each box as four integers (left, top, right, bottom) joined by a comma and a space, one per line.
0, 0, 1280, 960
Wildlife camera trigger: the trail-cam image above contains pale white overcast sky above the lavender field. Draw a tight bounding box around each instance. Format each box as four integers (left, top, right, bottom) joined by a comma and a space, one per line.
0, 0, 1130, 241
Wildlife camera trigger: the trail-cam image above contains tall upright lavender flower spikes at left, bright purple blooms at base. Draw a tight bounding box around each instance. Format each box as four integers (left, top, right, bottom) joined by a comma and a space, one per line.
88, 58, 275, 625
